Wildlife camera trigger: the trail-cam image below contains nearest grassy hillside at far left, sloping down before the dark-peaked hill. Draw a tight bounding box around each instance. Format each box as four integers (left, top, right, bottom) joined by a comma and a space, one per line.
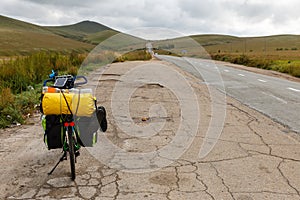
0, 15, 93, 56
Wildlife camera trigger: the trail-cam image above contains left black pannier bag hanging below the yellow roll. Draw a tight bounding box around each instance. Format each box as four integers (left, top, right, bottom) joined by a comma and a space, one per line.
44, 115, 64, 150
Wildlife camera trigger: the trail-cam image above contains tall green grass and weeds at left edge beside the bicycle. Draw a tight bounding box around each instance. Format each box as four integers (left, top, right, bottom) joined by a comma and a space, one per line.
0, 52, 85, 128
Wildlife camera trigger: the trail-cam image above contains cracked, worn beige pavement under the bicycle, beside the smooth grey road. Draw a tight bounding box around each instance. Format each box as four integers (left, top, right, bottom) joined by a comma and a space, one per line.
0, 60, 300, 200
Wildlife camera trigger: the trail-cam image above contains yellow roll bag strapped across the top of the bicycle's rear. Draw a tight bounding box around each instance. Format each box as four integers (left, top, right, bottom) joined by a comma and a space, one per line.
42, 89, 95, 117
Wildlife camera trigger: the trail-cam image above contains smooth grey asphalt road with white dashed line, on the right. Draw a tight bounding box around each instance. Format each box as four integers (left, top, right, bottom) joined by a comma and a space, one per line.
157, 55, 300, 133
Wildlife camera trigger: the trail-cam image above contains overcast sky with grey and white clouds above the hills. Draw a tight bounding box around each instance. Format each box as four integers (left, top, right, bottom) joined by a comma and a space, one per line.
0, 0, 300, 36
